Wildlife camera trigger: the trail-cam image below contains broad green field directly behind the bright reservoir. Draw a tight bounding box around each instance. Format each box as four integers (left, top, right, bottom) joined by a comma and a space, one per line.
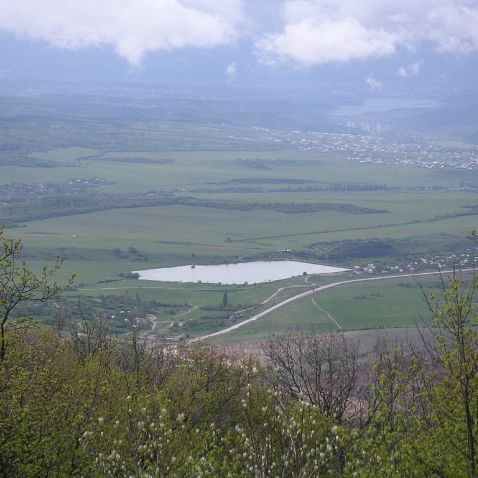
13, 192, 477, 272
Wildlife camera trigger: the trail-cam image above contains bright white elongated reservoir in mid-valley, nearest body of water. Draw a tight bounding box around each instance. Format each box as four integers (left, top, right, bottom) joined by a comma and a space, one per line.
133, 261, 348, 284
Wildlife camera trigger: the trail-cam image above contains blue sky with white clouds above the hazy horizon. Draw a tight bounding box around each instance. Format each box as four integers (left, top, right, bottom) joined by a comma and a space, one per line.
0, 0, 478, 88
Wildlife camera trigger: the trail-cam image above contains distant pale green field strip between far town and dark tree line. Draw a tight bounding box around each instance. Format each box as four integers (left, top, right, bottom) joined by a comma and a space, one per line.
0, 139, 478, 193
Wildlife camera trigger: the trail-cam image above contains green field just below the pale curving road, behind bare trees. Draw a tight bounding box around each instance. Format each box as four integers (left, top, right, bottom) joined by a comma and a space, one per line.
210, 276, 446, 343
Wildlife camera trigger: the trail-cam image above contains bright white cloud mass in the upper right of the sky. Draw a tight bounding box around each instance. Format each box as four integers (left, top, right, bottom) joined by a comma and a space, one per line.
256, 0, 478, 66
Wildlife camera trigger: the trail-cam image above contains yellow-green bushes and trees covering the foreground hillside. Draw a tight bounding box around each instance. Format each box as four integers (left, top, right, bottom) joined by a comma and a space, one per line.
0, 270, 478, 477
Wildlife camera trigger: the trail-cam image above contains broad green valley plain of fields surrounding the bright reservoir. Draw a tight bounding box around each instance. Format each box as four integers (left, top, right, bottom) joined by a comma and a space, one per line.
0, 94, 478, 341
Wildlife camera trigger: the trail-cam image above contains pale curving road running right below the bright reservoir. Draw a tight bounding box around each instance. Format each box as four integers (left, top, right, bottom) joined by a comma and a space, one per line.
189, 269, 474, 343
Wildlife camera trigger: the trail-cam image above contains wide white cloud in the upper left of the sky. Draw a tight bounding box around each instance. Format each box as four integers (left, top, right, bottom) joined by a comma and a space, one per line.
0, 0, 243, 65
